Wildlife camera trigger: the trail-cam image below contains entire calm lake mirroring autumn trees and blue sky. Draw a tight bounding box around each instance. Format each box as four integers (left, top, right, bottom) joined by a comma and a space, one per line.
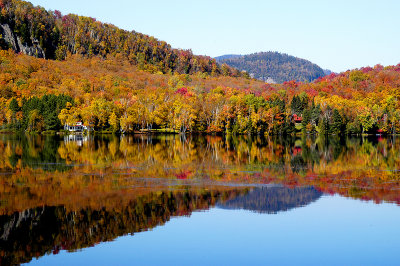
0, 135, 400, 265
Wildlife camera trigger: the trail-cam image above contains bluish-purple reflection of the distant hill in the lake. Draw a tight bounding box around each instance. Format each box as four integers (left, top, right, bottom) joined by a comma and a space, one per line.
218, 186, 322, 213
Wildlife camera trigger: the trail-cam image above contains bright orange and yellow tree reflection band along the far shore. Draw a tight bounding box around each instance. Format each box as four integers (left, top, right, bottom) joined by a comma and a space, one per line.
0, 135, 400, 207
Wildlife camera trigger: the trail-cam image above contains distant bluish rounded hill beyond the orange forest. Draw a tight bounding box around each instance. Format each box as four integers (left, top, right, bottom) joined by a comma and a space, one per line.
216, 52, 325, 83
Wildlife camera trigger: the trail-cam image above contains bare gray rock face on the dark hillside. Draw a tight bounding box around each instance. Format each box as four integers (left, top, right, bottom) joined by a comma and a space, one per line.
0, 24, 46, 58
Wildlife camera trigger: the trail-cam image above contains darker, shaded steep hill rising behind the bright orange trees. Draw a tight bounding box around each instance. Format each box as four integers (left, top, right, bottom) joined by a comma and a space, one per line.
0, 0, 241, 76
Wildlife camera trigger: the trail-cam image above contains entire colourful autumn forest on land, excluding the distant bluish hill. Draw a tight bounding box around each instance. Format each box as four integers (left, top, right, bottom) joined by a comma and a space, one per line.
0, 0, 400, 135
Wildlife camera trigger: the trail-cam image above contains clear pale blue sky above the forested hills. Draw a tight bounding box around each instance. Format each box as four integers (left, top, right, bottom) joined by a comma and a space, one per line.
31, 0, 400, 72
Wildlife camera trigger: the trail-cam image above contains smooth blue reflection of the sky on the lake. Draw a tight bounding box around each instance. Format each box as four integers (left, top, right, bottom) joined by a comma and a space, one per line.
28, 196, 400, 265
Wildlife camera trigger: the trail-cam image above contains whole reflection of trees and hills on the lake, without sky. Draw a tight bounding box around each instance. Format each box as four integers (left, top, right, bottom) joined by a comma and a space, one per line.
0, 135, 400, 264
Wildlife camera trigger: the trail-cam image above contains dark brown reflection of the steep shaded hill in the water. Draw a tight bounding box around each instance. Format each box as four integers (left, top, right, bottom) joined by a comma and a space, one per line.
0, 189, 244, 265
